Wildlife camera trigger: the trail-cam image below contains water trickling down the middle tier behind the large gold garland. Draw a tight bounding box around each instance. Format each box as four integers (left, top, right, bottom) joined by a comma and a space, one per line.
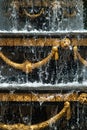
0, 47, 87, 86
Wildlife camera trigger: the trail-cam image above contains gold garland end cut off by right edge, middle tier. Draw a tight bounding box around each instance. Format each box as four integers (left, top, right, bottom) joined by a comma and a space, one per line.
73, 46, 87, 66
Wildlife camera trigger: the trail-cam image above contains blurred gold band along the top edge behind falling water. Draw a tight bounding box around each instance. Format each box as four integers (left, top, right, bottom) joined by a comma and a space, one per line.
13, 0, 76, 8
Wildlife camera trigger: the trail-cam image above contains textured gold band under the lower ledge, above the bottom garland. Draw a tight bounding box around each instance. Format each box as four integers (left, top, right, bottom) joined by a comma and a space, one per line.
0, 93, 87, 103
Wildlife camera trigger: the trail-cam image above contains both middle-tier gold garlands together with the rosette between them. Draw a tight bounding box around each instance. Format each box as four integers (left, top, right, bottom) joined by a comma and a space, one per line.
0, 38, 87, 73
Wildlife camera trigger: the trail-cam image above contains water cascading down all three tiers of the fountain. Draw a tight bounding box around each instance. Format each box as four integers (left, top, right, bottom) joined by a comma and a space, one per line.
0, 0, 87, 130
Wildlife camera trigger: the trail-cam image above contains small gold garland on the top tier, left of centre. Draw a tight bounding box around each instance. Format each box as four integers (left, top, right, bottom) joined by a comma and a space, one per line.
24, 8, 44, 19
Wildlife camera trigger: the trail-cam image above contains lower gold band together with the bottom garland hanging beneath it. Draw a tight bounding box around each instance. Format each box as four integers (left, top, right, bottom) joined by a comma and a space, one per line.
0, 93, 87, 130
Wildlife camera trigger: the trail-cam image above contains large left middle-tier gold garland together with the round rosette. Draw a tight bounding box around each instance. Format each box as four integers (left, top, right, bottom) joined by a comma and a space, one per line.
0, 38, 70, 73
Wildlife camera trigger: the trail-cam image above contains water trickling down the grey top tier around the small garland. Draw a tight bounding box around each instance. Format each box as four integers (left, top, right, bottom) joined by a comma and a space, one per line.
0, 0, 84, 32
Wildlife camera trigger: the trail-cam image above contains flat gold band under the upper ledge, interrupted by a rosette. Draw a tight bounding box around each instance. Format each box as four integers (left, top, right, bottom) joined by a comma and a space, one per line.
0, 36, 87, 47
